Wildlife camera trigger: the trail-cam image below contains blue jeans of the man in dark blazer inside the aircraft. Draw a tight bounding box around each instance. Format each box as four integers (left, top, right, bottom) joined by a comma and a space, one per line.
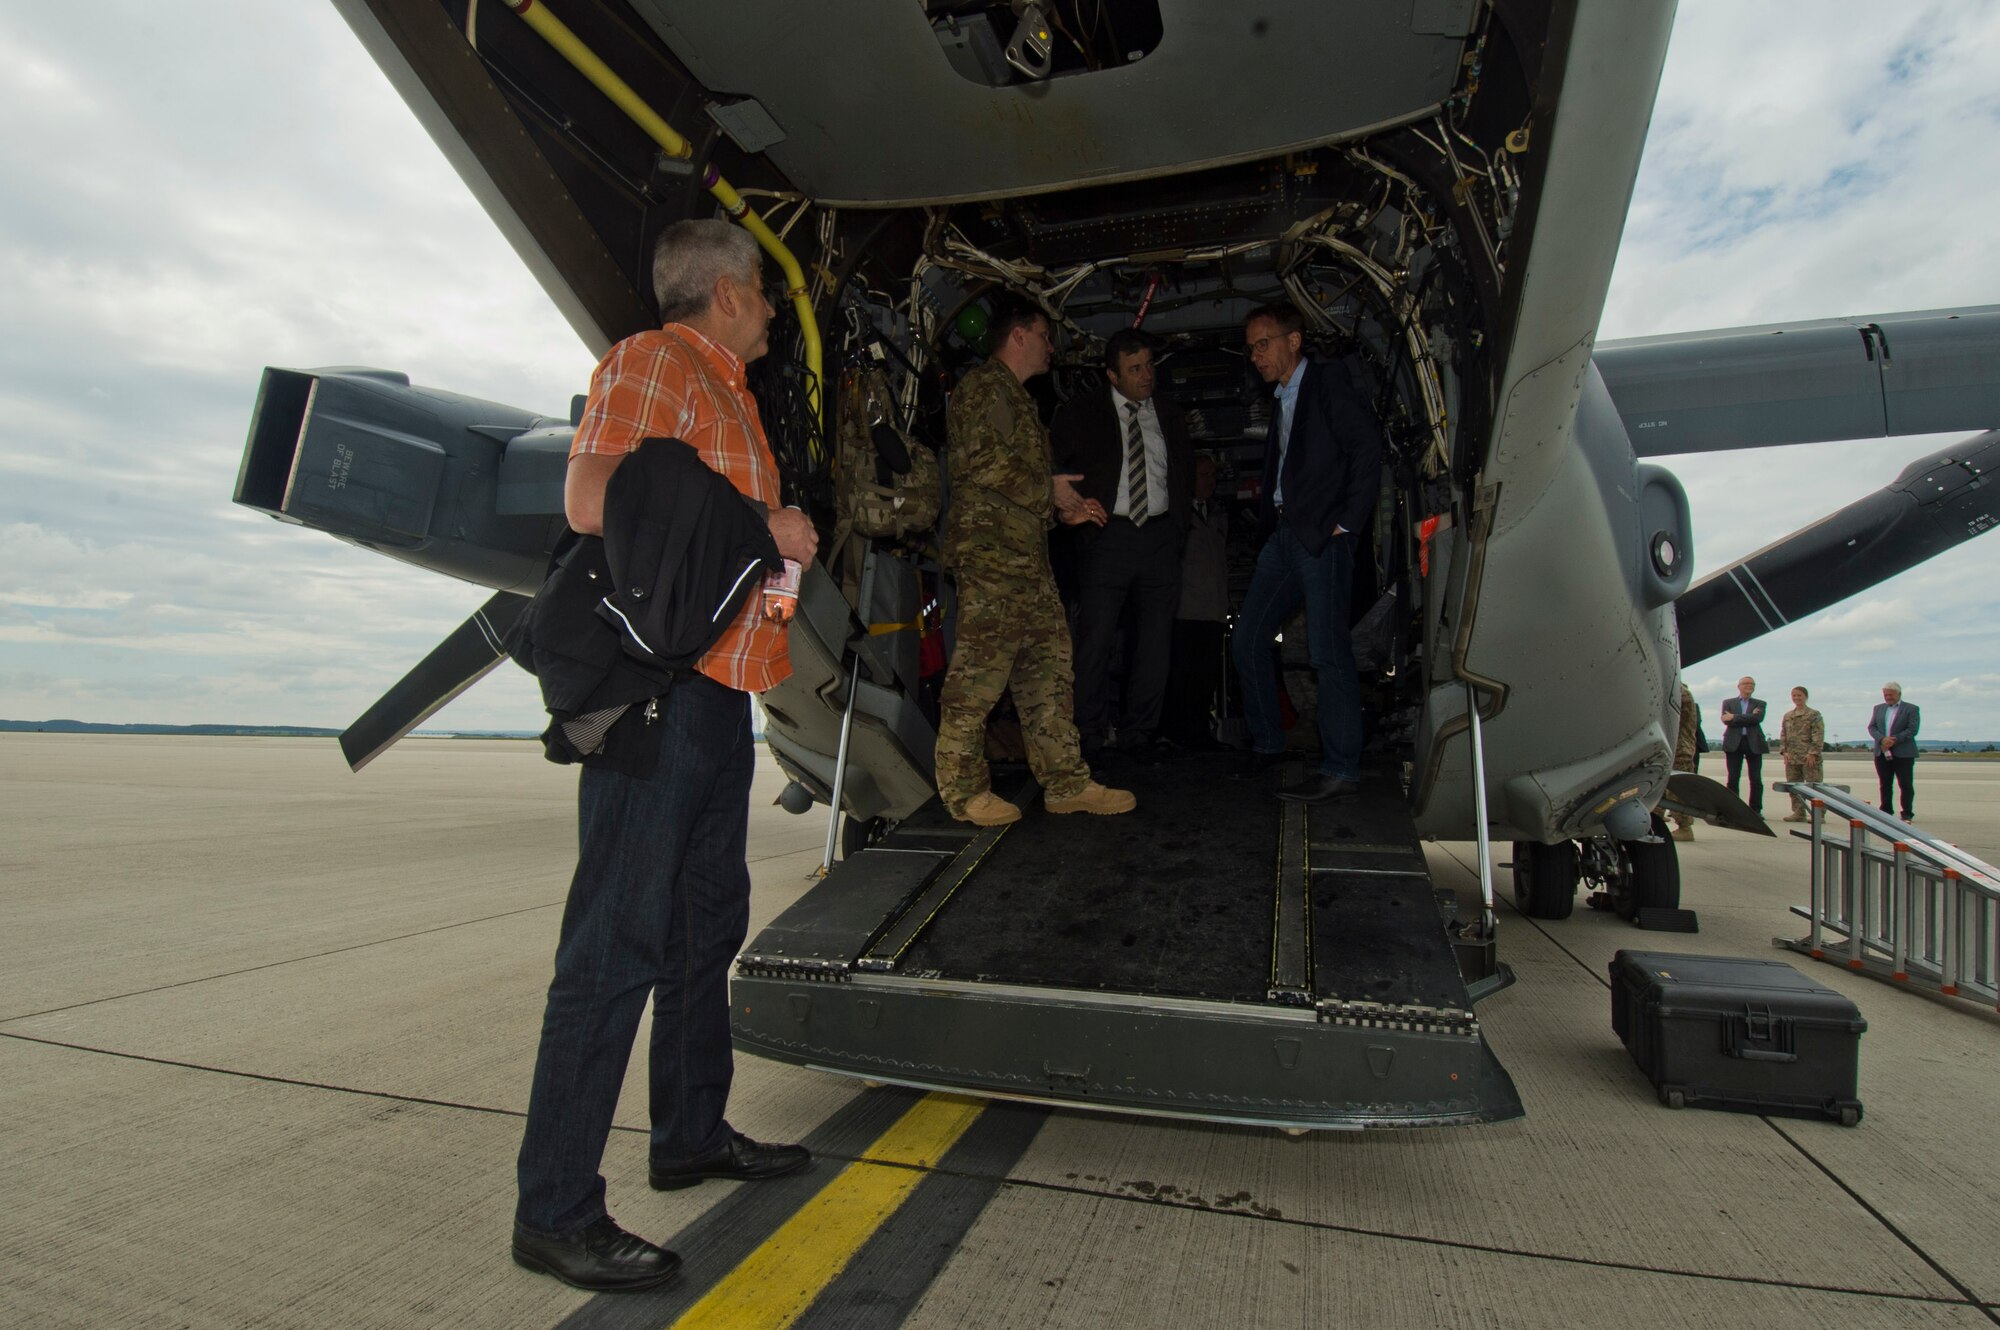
1230, 522, 1362, 780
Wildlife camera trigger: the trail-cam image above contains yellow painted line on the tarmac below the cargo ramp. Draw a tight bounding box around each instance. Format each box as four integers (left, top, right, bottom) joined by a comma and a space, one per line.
672, 1094, 986, 1330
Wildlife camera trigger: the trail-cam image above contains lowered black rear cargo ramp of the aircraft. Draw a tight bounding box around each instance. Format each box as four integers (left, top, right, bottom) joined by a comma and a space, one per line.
732, 754, 1522, 1128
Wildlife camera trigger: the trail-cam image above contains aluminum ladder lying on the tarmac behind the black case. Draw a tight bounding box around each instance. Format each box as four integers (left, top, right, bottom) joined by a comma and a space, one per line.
1772, 780, 2000, 1006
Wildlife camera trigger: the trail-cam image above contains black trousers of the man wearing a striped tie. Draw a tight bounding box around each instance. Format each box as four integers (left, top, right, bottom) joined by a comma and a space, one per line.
1076, 518, 1180, 744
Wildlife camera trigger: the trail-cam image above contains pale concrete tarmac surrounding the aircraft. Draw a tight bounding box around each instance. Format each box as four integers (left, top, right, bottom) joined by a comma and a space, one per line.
0, 734, 2000, 1330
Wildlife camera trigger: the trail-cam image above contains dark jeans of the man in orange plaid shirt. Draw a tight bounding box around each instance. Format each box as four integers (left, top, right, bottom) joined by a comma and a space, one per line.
514, 676, 754, 1234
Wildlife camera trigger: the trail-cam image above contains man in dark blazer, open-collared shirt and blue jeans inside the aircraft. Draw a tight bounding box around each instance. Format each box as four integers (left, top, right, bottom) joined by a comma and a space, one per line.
1230, 304, 1382, 804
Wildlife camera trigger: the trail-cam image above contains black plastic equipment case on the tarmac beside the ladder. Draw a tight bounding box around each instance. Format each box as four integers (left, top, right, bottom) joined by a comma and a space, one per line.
1612, 952, 1868, 1126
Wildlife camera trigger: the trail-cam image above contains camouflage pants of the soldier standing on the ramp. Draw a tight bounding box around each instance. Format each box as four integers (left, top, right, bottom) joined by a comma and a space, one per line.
938, 570, 1090, 816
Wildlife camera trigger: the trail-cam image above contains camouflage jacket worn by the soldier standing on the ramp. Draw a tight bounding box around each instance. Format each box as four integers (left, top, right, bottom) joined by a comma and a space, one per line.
944, 360, 1056, 576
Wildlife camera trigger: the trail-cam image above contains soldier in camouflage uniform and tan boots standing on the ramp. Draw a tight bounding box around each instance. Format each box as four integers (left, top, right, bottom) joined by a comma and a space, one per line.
938, 306, 1136, 826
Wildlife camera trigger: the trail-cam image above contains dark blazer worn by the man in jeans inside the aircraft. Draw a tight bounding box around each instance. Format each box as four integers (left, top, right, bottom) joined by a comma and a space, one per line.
1258, 360, 1382, 554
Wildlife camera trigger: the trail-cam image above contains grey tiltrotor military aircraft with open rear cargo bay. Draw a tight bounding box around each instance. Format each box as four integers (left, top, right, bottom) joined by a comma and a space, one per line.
236, 0, 2000, 1128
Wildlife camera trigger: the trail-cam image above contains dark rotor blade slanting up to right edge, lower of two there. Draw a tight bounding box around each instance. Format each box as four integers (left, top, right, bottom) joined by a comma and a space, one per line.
1674, 430, 2000, 666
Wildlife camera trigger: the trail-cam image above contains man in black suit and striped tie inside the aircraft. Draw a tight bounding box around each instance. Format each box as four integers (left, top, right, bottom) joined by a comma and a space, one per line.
1050, 328, 1194, 754
